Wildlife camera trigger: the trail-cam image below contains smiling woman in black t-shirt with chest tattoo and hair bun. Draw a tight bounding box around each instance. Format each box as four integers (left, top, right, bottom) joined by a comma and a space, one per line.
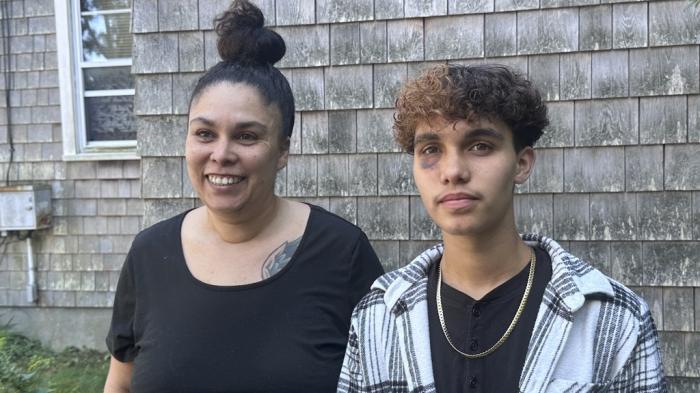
105, 1, 382, 392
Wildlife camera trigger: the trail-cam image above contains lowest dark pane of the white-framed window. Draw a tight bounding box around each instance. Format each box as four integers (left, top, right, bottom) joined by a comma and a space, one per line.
85, 96, 136, 142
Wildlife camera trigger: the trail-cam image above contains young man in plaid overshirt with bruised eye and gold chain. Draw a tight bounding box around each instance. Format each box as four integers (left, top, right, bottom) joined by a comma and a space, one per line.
338, 65, 666, 393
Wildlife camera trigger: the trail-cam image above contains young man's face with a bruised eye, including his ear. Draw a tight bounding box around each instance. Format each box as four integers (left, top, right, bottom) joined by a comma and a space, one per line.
413, 113, 535, 236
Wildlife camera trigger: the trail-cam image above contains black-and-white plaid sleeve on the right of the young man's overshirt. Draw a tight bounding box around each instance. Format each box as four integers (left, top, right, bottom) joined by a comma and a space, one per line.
610, 301, 667, 393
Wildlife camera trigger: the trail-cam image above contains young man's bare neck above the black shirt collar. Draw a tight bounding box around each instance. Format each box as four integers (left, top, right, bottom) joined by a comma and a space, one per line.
441, 226, 531, 300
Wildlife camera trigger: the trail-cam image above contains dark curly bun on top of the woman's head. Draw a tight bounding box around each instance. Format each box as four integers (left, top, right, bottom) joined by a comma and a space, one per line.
214, 0, 287, 64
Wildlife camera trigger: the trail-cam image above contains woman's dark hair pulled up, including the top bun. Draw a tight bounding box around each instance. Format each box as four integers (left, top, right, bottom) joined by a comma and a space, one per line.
190, 0, 294, 137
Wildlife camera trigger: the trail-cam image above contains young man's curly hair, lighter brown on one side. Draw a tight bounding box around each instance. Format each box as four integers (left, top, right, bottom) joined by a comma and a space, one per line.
394, 64, 549, 153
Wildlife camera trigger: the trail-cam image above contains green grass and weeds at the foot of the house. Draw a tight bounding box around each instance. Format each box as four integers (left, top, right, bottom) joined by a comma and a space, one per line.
0, 327, 109, 393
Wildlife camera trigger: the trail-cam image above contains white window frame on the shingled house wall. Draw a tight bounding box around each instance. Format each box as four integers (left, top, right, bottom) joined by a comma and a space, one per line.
54, 0, 140, 161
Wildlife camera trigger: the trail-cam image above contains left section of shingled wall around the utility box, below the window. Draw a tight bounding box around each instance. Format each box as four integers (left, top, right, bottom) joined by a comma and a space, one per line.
0, 0, 143, 348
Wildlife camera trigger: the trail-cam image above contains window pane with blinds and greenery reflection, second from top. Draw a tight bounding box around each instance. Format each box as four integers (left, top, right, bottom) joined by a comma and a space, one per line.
81, 13, 131, 61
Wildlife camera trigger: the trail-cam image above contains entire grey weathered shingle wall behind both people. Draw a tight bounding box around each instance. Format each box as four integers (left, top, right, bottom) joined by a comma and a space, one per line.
0, 0, 700, 392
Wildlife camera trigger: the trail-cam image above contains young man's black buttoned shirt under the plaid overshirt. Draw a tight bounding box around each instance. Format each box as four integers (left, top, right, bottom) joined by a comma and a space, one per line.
428, 248, 552, 393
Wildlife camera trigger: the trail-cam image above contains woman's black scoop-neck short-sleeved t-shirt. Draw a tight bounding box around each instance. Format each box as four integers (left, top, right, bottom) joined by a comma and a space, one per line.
107, 206, 382, 393
